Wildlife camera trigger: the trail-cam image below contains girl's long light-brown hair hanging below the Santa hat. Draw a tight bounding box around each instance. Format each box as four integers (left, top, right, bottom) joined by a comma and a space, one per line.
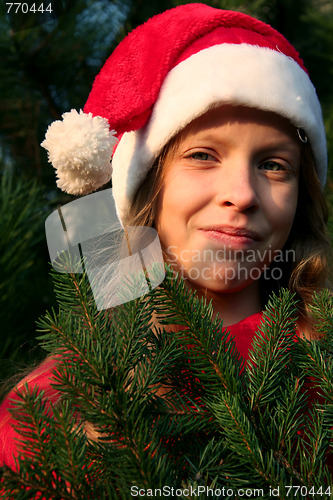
126, 133, 330, 325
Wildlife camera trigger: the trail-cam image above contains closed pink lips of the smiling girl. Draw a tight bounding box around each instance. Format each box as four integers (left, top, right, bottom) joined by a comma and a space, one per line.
199, 226, 262, 247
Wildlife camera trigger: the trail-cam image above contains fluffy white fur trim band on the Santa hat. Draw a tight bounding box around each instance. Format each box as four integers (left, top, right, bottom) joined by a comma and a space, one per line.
112, 44, 327, 221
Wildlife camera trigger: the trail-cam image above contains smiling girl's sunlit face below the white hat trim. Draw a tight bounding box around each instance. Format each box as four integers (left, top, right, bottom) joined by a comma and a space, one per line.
155, 106, 300, 293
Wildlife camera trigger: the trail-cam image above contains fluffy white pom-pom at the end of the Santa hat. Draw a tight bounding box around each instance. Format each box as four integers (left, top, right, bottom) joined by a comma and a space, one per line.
41, 109, 117, 194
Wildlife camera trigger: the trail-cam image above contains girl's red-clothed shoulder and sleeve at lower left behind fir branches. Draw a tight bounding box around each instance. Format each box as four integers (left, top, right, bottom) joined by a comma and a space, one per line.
0, 358, 59, 468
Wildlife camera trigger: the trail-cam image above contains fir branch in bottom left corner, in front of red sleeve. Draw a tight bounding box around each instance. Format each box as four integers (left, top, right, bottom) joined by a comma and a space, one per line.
4, 386, 92, 499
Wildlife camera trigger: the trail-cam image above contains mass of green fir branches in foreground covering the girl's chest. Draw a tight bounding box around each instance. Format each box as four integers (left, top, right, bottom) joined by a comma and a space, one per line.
2, 269, 333, 500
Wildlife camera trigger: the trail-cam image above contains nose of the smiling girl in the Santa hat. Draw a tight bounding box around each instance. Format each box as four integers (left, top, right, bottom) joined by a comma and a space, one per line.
216, 162, 259, 212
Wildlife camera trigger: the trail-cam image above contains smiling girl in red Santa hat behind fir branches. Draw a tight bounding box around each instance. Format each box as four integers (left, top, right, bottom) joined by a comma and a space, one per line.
0, 3, 329, 476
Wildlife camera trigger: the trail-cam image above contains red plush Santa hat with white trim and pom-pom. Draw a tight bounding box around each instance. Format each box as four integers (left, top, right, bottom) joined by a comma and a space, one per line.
42, 3, 327, 225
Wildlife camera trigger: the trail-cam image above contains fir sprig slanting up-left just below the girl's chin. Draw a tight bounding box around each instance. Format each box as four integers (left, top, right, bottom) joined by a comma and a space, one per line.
152, 269, 242, 393
